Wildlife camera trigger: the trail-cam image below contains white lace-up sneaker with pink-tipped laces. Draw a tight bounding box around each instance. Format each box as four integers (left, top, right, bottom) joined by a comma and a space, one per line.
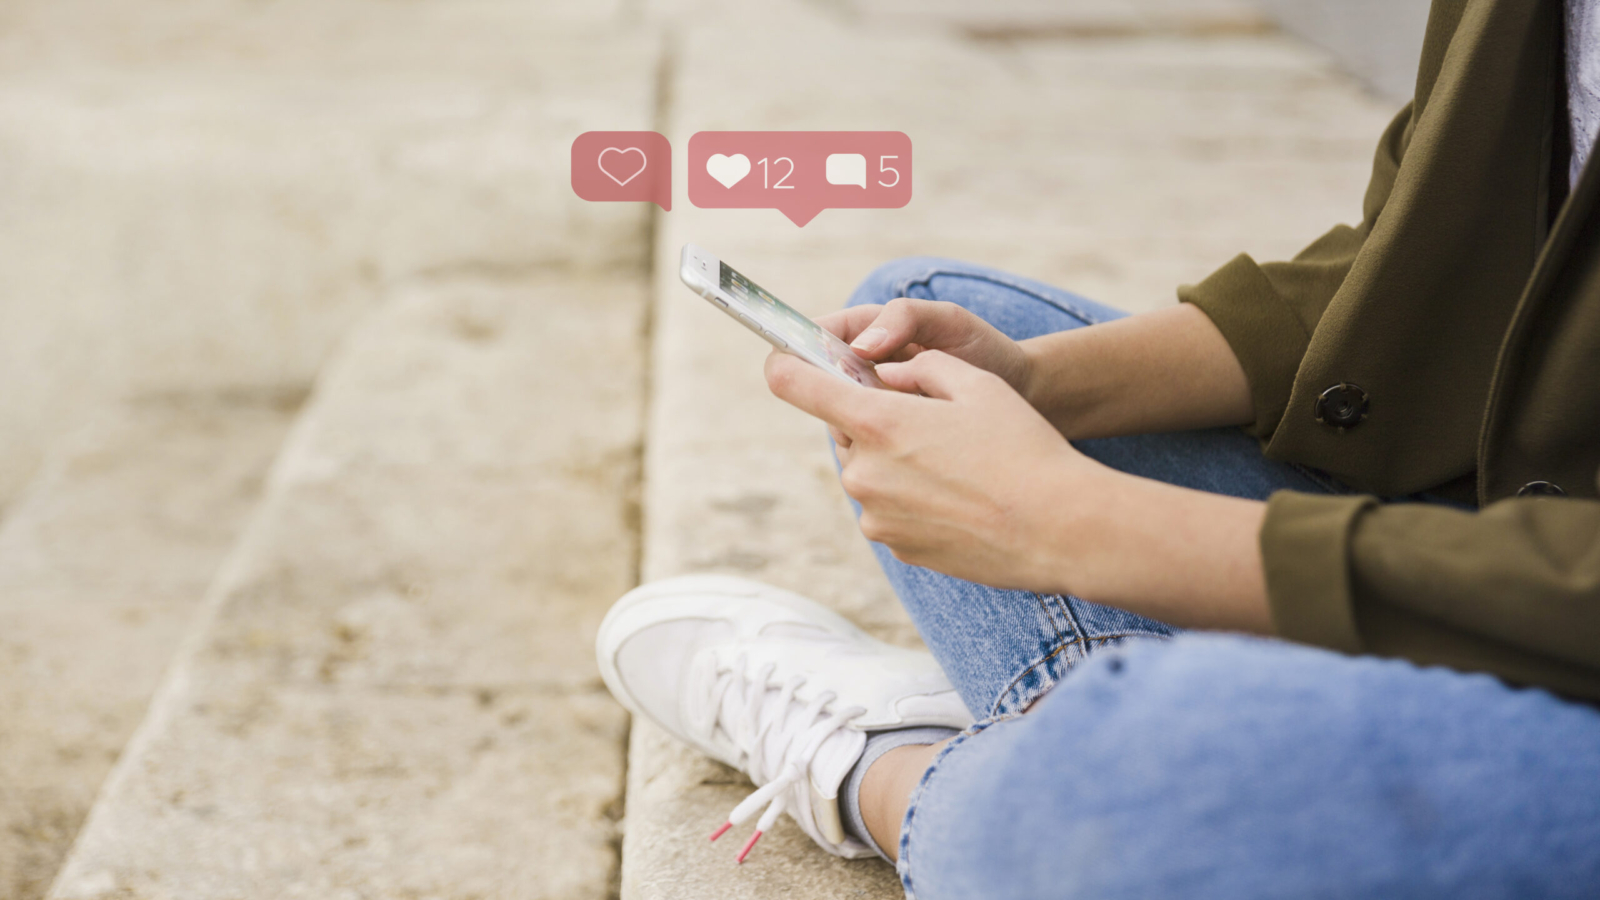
595, 575, 973, 862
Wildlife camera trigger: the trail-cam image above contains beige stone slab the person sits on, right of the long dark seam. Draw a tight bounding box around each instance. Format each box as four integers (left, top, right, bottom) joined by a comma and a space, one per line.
622, 6, 1389, 900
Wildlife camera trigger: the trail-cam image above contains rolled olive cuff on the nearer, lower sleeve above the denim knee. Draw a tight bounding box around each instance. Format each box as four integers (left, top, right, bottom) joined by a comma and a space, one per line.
1261, 490, 1378, 653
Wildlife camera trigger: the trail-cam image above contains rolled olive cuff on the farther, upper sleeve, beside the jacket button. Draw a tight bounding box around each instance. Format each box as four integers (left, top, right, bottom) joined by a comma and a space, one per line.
1178, 253, 1310, 439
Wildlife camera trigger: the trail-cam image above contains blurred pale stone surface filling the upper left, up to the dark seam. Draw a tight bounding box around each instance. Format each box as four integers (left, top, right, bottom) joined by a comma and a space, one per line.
0, 0, 658, 506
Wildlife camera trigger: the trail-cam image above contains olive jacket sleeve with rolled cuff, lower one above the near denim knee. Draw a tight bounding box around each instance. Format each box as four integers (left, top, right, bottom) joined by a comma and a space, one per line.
1261, 492, 1600, 698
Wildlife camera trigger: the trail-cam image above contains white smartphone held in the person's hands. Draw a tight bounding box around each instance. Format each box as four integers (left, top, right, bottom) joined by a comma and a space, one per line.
678, 243, 886, 388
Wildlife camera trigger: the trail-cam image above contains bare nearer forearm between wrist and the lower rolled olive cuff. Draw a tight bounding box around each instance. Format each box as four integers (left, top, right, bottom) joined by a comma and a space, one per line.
1046, 469, 1274, 634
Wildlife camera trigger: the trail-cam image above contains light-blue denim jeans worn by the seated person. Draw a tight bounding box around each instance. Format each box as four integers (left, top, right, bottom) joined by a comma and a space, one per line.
850, 259, 1600, 900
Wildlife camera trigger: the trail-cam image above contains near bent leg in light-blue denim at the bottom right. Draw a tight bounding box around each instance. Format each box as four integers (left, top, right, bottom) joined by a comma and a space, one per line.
904, 636, 1600, 898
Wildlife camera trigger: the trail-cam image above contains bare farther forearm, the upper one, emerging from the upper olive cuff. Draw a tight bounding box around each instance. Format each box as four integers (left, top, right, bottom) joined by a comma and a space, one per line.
1021, 304, 1254, 439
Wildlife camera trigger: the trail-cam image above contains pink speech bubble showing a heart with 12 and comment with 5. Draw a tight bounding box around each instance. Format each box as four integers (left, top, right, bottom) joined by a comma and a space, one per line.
690, 131, 910, 227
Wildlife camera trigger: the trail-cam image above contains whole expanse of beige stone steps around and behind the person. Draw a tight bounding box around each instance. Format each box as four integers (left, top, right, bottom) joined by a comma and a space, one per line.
0, 0, 1390, 900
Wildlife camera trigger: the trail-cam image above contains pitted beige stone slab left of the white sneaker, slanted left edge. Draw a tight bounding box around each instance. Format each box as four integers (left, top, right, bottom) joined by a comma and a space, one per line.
51, 277, 645, 898
